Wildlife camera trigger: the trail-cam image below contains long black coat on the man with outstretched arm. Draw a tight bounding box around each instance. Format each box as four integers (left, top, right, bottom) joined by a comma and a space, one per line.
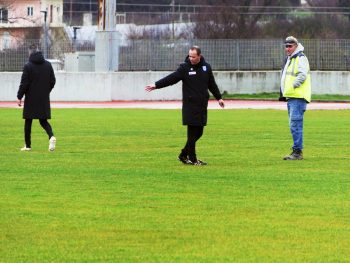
155, 56, 222, 126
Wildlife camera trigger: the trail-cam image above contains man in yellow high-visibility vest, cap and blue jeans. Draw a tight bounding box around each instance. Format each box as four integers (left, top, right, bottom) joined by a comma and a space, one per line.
280, 36, 311, 160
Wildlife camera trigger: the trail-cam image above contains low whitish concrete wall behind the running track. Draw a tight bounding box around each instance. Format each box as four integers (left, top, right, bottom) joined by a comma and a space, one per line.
0, 71, 350, 101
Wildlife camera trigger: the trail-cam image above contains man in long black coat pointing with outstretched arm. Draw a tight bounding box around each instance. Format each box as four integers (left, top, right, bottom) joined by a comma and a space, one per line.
146, 46, 225, 165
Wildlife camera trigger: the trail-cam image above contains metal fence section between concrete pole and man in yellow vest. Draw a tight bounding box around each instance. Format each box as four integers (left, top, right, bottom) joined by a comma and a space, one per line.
119, 40, 284, 70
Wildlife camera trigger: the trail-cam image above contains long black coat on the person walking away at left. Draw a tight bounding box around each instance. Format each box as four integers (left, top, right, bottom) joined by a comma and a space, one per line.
17, 52, 56, 119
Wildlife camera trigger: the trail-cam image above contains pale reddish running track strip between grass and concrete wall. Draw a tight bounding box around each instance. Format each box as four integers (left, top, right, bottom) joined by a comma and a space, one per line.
0, 100, 350, 110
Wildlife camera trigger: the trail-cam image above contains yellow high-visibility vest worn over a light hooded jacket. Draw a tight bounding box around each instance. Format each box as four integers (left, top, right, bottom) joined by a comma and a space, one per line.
283, 55, 311, 102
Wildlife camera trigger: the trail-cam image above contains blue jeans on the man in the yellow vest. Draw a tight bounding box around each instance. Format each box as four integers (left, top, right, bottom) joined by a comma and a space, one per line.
287, 99, 307, 150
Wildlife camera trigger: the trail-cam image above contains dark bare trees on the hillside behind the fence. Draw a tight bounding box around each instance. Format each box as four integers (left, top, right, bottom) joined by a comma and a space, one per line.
117, 0, 350, 39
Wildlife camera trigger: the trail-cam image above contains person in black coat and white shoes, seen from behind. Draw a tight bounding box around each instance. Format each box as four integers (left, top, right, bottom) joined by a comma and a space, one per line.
17, 45, 56, 151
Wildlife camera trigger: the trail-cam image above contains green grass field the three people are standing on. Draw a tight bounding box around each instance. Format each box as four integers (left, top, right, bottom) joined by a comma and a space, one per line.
0, 109, 350, 262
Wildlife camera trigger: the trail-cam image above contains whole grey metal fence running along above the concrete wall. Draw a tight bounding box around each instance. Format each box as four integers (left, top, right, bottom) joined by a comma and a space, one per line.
0, 39, 350, 71
